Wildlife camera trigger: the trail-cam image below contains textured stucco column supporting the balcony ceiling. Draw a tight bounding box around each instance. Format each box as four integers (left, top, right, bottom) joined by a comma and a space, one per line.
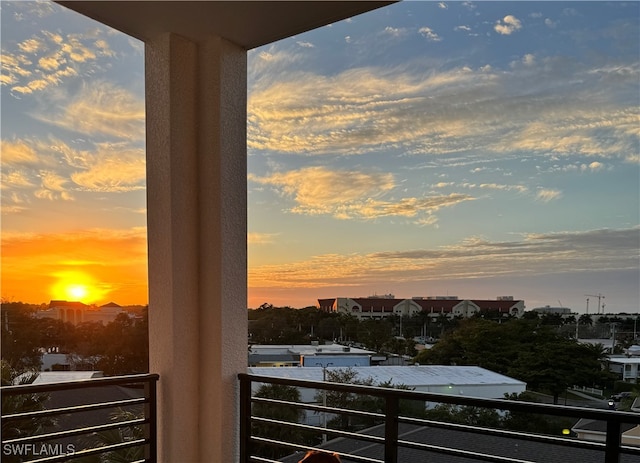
145, 34, 247, 463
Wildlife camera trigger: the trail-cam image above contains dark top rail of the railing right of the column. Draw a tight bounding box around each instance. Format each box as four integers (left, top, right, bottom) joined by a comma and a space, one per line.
238, 373, 640, 424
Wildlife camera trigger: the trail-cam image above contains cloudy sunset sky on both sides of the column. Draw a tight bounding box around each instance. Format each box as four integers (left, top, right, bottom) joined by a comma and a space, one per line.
0, 1, 640, 313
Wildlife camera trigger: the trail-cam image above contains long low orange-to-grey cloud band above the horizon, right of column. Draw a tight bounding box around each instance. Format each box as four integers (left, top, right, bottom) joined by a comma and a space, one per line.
249, 228, 639, 288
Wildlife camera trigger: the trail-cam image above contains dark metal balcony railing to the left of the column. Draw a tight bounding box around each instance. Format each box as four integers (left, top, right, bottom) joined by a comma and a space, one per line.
0, 374, 158, 463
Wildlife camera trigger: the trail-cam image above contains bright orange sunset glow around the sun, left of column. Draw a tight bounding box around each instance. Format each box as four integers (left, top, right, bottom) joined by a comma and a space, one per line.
1, 228, 148, 305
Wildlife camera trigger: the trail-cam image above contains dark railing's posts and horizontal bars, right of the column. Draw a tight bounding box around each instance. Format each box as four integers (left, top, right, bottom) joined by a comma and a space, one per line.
238, 373, 640, 463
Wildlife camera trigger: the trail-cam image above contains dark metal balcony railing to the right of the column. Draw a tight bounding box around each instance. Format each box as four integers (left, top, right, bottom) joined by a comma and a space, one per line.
239, 374, 640, 463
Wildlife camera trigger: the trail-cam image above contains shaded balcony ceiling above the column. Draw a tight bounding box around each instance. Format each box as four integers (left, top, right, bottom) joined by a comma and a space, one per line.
57, 0, 394, 50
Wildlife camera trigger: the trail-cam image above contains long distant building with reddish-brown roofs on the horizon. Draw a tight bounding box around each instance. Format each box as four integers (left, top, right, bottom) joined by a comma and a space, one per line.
318, 295, 524, 319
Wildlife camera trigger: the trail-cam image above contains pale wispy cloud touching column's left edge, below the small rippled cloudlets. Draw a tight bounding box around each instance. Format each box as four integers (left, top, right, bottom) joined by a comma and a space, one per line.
33, 81, 145, 140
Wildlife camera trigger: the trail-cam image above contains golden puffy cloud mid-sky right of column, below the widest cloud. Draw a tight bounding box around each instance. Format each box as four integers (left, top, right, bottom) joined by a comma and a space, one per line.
249, 167, 473, 223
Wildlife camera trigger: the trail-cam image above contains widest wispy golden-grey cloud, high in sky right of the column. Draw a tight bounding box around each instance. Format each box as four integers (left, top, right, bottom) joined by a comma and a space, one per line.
248, 54, 640, 165
